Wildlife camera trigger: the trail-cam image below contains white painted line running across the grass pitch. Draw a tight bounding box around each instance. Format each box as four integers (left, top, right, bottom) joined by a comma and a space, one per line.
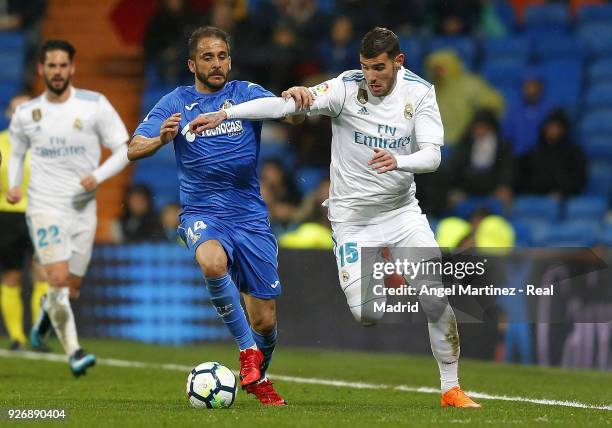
0, 349, 612, 411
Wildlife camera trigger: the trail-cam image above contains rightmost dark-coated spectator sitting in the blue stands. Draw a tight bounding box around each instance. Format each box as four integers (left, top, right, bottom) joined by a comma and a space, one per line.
519, 110, 587, 198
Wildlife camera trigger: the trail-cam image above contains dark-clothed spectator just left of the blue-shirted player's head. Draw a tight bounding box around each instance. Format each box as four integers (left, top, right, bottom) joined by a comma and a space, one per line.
144, 0, 196, 84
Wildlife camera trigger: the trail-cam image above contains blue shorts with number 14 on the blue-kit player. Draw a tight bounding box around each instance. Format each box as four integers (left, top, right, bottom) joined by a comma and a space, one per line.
178, 213, 282, 299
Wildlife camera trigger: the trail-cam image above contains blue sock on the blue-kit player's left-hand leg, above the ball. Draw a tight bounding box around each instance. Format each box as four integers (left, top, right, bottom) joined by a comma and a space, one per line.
206, 274, 255, 351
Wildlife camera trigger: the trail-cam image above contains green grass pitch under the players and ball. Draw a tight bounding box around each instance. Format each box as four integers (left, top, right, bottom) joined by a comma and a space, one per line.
0, 340, 612, 428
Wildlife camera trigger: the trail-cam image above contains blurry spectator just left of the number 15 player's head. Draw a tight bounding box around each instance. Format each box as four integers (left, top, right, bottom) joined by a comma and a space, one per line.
319, 16, 359, 76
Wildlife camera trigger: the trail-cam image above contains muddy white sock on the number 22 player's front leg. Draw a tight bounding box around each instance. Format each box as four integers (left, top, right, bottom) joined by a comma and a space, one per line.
44, 287, 80, 356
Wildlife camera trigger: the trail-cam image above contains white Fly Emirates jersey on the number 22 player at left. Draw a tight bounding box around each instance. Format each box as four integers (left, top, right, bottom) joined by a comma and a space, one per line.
9, 88, 129, 212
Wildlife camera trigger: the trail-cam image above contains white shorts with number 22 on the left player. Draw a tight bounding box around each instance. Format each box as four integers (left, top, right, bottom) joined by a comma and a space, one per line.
26, 208, 97, 277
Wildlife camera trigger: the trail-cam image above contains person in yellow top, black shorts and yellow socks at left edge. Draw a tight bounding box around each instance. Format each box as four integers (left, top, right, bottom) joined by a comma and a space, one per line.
0, 95, 48, 350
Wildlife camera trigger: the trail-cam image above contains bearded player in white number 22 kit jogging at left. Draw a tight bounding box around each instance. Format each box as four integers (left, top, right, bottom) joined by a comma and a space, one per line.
7, 40, 129, 376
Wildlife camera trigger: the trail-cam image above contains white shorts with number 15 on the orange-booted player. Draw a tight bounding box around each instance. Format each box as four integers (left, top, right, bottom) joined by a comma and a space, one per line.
332, 211, 440, 323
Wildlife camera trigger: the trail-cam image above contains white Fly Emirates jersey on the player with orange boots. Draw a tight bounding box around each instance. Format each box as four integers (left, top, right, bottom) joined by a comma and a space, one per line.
310, 67, 444, 223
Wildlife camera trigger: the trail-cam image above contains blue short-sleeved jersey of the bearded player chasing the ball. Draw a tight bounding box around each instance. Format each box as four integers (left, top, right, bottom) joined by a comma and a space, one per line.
134, 80, 274, 221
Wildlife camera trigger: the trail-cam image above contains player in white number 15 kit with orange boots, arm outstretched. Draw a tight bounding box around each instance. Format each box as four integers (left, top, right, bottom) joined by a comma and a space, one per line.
191, 27, 480, 407
